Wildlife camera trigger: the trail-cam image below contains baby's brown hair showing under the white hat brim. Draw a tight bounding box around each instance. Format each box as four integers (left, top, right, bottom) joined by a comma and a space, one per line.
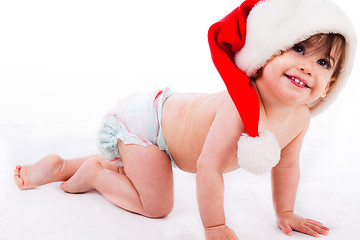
299, 33, 345, 79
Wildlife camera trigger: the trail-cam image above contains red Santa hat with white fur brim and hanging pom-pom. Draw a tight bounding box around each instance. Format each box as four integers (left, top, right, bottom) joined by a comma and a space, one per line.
208, 0, 356, 174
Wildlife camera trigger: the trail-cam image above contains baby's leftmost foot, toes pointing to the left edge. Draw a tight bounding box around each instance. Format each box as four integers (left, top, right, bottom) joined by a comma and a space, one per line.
14, 154, 64, 190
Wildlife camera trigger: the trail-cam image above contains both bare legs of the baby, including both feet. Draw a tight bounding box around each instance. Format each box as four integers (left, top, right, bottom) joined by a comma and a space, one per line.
14, 141, 174, 218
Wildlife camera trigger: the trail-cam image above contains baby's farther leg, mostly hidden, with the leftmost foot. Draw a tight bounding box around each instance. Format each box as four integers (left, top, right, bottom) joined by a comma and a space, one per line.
14, 154, 110, 190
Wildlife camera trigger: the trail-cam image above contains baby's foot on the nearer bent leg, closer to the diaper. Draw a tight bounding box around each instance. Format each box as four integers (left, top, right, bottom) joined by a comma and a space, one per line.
60, 158, 103, 193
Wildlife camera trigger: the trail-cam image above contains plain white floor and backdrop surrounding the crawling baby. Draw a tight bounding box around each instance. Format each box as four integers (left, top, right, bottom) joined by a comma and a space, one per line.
0, 0, 360, 240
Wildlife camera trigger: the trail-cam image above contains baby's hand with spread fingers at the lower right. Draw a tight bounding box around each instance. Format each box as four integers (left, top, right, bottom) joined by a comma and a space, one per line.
277, 211, 329, 237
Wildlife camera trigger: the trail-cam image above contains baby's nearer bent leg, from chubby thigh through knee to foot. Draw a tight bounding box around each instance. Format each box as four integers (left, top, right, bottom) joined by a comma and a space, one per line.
62, 141, 174, 218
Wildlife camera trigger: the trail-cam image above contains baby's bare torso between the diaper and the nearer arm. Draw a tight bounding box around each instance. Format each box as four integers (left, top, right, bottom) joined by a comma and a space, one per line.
162, 93, 219, 173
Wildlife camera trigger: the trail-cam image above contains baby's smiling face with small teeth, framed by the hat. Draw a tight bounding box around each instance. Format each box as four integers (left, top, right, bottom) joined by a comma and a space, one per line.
256, 44, 335, 105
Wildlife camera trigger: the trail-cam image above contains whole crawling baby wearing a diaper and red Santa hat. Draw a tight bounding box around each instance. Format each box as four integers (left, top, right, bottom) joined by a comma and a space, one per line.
15, 0, 356, 239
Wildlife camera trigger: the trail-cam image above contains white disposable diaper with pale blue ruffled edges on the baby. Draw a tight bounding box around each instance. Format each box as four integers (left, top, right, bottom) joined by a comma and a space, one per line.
97, 88, 174, 167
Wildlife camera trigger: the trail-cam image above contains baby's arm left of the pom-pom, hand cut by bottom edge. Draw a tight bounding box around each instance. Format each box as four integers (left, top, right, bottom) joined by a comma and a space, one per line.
196, 104, 240, 239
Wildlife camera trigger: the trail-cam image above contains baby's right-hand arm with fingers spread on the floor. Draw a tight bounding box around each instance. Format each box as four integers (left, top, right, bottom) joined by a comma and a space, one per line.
271, 118, 329, 237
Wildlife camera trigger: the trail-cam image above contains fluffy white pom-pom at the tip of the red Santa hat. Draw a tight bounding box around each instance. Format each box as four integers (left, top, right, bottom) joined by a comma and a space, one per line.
237, 130, 281, 174
